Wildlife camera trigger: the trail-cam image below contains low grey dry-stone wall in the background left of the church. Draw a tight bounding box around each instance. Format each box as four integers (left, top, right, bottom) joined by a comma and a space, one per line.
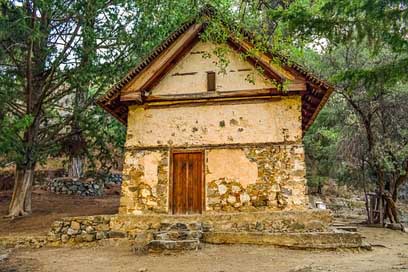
47, 178, 104, 196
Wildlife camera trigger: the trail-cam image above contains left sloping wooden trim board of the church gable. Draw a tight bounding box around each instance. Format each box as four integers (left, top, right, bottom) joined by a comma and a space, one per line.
120, 24, 203, 101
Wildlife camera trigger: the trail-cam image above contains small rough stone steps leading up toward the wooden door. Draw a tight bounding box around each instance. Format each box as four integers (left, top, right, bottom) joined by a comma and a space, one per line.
146, 223, 203, 252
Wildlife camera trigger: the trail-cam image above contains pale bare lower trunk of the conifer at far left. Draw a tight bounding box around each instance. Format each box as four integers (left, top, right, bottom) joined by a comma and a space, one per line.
8, 167, 34, 218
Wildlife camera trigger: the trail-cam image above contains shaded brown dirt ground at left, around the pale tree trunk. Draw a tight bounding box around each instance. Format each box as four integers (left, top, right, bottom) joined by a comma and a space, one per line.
0, 189, 119, 236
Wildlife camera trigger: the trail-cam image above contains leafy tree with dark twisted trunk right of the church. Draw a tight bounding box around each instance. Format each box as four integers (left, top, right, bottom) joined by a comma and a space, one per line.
305, 41, 408, 223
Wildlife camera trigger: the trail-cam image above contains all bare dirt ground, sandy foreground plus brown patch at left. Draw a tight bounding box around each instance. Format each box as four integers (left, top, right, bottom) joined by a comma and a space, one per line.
0, 191, 408, 272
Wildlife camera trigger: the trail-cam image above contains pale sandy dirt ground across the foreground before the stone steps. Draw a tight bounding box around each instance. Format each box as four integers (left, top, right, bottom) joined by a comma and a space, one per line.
0, 227, 408, 272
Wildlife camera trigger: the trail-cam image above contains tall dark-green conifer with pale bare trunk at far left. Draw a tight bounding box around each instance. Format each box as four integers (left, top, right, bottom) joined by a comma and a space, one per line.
0, 1, 139, 217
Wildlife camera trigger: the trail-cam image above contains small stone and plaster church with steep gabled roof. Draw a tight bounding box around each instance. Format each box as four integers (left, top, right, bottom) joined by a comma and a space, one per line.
97, 16, 333, 216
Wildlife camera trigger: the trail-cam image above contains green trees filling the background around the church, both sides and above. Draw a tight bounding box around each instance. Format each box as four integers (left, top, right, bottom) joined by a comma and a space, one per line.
0, 0, 408, 221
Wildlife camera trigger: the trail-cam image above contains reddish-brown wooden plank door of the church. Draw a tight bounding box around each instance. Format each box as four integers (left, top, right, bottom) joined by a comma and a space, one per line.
172, 152, 204, 214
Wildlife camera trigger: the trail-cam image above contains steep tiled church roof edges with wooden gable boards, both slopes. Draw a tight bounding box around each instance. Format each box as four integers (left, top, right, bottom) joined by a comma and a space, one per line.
97, 15, 333, 131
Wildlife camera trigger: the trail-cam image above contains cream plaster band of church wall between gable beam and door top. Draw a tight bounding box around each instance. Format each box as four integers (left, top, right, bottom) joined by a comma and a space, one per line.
126, 96, 302, 147
